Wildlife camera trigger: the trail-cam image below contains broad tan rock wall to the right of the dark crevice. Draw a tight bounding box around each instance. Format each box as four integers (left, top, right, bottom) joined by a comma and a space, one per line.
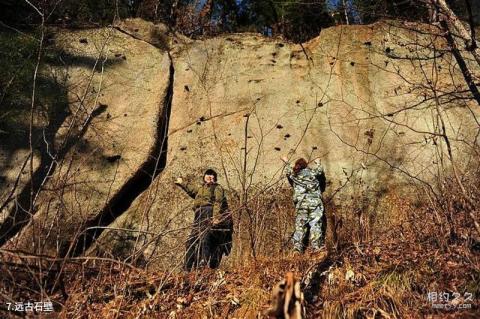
91, 23, 478, 267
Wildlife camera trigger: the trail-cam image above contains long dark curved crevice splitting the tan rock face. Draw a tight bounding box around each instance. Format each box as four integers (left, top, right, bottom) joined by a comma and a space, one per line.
70, 54, 175, 256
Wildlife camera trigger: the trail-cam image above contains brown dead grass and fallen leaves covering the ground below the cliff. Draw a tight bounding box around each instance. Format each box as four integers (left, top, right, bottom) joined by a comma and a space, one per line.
0, 181, 480, 318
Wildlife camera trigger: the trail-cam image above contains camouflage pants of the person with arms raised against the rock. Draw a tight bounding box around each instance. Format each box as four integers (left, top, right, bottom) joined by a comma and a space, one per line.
293, 198, 324, 252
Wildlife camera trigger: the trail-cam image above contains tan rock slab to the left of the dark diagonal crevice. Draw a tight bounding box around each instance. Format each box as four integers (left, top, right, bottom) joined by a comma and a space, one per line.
0, 24, 170, 255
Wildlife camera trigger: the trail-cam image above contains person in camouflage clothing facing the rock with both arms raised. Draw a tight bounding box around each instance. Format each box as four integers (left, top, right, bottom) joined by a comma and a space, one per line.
282, 157, 325, 252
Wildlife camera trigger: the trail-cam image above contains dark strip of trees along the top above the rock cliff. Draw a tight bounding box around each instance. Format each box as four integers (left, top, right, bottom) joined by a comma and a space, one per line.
0, 0, 480, 42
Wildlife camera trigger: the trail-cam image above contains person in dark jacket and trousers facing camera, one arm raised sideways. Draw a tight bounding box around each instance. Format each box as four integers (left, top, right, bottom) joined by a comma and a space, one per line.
175, 169, 233, 271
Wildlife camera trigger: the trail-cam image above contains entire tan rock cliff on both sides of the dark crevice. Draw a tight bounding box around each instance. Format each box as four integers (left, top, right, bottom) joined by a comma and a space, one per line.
1, 20, 478, 267
